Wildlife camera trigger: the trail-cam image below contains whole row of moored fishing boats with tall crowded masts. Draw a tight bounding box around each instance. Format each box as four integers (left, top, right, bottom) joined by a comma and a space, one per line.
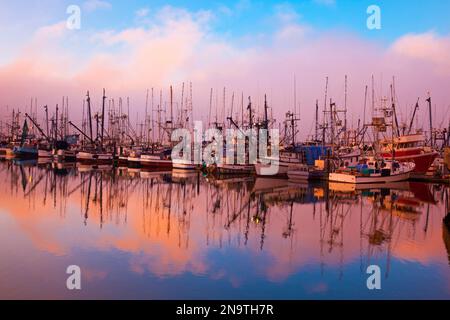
0, 76, 450, 183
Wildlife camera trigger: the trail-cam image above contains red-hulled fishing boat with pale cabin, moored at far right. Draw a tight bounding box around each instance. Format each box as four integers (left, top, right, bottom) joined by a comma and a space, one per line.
380, 134, 439, 174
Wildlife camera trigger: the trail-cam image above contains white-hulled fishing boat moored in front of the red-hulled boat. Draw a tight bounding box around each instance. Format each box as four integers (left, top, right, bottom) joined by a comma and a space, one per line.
329, 158, 415, 184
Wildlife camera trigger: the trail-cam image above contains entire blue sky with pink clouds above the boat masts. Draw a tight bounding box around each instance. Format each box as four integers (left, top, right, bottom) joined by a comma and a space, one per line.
0, 0, 450, 138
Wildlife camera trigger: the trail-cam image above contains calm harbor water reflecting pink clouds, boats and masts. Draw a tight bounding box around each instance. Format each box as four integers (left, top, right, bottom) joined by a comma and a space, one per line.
0, 160, 450, 299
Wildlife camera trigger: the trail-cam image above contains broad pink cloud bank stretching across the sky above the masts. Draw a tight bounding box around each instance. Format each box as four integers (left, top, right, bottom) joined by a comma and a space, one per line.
0, 7, 450, 137
